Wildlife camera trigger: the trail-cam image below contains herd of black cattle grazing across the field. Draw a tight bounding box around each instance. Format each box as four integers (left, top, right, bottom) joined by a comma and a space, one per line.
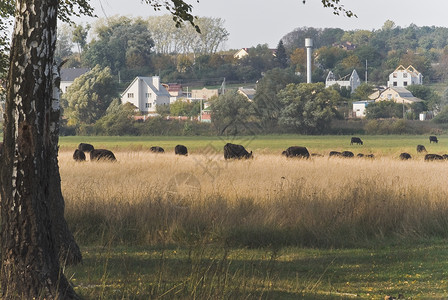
73, 136, 448, 161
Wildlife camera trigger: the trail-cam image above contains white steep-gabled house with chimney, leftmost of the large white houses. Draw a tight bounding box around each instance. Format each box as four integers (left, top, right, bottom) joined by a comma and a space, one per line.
121, 76, 170, 113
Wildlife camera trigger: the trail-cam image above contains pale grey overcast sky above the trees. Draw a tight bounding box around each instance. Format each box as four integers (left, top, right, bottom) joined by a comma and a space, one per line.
78, 0, 448, 49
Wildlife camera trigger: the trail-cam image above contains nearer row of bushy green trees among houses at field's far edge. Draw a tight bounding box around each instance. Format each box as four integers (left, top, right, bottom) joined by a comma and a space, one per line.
61, 65, 448, 134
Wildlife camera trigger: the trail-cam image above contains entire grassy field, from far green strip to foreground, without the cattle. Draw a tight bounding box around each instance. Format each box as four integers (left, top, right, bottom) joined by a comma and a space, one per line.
60, 136, 448, 299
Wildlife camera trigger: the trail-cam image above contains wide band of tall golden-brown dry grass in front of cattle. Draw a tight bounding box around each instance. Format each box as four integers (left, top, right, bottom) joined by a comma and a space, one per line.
60, 151, 448, 247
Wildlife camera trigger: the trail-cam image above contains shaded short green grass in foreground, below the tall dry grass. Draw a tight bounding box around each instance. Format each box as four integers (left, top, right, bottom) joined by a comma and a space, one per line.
66, 240, 448, 299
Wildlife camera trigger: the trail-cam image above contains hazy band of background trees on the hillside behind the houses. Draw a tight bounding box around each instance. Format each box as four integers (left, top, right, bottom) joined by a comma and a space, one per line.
50, 16, 448, 94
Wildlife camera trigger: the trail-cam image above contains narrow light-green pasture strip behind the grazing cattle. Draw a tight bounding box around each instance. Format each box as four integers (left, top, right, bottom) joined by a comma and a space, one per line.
60, 135, 448, 156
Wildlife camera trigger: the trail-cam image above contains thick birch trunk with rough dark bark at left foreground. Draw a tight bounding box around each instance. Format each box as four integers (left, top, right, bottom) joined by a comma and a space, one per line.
0, 0, 81, 299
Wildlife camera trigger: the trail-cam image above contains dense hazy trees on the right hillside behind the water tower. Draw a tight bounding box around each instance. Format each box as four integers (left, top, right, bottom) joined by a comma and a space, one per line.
282, 20, 448, 84
